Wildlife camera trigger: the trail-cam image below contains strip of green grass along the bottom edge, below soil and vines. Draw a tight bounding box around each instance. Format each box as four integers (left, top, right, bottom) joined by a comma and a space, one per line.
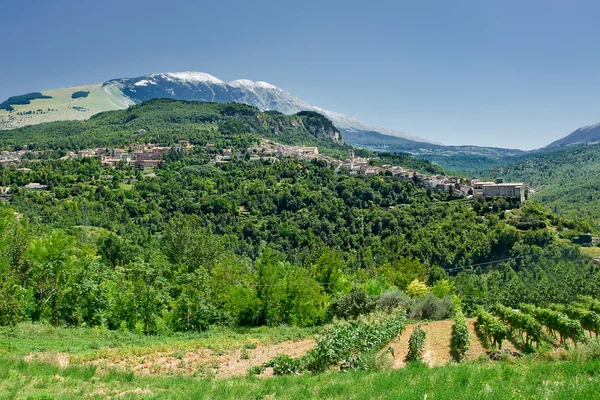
0, 357, 600, 400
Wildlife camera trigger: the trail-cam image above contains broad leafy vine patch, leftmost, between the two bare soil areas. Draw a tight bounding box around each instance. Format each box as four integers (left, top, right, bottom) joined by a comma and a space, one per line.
267, 311, 406, 375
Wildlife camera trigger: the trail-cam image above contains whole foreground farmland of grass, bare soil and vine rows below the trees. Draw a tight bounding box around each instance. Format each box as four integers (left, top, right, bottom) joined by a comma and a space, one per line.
5, 298, 600, 399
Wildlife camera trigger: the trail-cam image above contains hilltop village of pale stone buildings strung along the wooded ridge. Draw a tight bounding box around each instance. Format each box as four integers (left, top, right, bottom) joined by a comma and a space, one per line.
0, 139, 529, 201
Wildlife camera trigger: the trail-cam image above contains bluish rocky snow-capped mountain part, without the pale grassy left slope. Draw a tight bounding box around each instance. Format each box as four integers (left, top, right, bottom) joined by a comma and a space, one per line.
103, 72, 428, 143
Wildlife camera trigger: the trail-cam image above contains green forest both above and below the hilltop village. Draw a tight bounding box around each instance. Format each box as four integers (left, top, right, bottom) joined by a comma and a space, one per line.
0, 100, 600, 334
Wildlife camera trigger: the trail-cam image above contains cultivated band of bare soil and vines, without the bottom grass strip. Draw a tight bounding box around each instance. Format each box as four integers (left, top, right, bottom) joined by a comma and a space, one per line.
7, 297, 600, 379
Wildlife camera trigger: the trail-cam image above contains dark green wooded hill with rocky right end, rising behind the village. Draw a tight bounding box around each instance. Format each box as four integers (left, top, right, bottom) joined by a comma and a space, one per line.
0, 99, 347, 150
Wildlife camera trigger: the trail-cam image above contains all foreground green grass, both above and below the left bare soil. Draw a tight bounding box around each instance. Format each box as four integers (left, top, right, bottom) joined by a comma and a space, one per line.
0, 324, 600, 400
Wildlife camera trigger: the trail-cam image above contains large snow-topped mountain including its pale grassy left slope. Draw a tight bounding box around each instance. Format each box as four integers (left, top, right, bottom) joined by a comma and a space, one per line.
0, 71, 426, 147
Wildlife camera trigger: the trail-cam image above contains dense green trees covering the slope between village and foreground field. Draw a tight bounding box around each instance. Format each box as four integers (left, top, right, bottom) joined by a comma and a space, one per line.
0, 155, 600, 333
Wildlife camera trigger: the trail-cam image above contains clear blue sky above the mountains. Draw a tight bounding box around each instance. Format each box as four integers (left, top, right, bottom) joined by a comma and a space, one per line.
0, 0, 600, 149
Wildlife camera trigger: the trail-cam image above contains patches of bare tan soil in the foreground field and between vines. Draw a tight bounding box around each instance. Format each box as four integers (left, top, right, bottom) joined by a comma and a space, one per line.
25, 319, 514, 378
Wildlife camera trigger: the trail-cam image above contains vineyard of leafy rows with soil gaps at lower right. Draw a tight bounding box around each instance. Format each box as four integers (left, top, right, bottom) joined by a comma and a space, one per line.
262, 297, 600, 375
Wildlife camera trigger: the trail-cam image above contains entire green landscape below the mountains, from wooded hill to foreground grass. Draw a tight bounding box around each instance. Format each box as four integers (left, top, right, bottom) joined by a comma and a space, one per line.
0, 86, 600, 398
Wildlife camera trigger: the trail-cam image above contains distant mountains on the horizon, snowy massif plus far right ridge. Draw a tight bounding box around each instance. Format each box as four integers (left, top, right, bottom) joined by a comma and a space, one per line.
0, 72, 600, 160
